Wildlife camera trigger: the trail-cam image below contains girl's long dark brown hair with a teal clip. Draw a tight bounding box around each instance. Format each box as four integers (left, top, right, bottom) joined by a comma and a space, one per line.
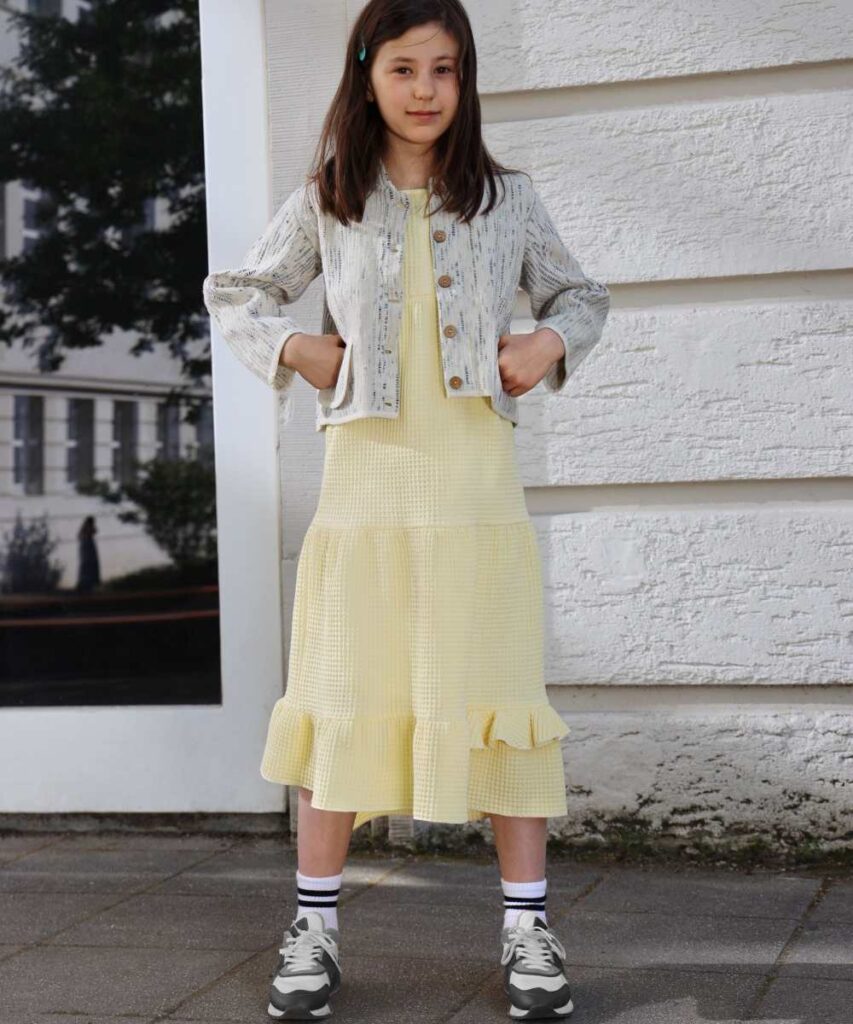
308, 0, 522, 224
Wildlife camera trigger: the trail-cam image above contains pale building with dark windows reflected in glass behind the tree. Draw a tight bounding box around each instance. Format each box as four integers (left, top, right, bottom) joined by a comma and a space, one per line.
0, 0, 213, 587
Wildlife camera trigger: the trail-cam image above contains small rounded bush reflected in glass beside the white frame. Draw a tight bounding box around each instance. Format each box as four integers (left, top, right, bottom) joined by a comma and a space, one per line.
77, 456, 216, 571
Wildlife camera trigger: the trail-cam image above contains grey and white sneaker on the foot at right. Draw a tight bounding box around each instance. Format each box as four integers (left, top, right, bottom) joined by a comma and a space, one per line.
501, 910, 574, 1020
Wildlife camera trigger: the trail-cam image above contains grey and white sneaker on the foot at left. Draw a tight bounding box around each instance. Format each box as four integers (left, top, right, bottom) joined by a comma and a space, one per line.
266, 910, 341, 1021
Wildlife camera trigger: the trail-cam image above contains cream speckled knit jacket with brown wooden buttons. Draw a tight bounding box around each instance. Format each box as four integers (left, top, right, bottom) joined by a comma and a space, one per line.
203, 161, 610, 430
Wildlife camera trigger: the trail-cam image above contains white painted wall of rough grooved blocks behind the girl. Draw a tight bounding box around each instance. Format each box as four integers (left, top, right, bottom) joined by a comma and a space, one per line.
267, 0, 853, 843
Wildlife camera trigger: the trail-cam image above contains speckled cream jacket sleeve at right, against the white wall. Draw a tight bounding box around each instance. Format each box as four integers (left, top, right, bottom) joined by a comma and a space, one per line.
519, 188, 610, 391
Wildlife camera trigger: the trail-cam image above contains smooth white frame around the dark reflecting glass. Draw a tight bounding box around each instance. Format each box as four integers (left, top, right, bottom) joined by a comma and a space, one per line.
0, 0, 287, 813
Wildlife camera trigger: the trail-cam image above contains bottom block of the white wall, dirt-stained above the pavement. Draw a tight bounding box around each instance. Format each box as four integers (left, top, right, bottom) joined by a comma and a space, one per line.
563, 706, 853, 847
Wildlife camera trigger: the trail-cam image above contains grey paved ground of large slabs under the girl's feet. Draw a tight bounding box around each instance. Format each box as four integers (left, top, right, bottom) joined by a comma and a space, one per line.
0, 833, 853, 1024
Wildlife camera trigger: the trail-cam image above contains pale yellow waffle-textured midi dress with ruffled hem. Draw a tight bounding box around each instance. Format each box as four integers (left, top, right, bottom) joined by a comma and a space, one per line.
256, 188, 569, 829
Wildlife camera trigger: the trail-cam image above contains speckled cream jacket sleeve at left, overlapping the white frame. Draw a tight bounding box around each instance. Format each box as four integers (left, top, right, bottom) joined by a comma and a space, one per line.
202, 184, 323, 390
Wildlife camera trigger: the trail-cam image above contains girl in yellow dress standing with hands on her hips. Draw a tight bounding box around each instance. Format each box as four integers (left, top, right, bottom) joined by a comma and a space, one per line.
204, 0, 609, 1019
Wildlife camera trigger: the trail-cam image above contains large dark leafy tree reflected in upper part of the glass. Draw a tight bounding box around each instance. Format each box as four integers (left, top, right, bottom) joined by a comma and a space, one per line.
0, 0, 210, 403
